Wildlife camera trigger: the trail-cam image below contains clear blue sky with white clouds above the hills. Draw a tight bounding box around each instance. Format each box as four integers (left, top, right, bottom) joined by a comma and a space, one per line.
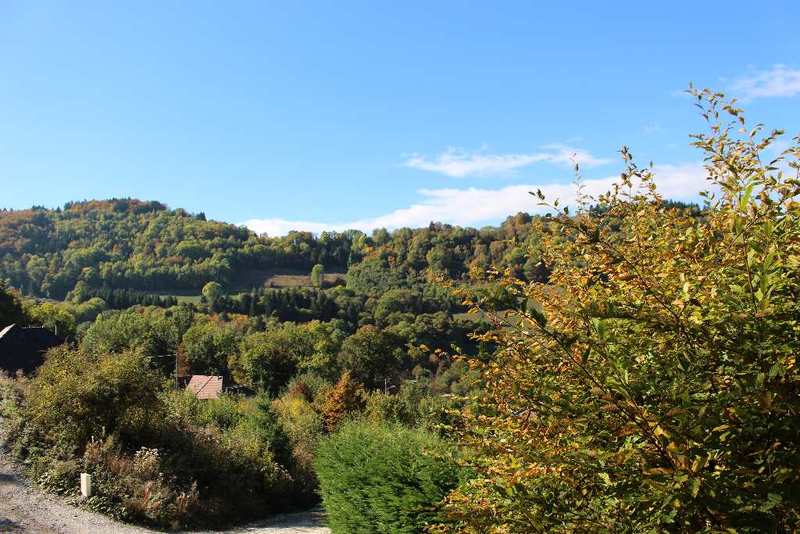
0, 0, 800, 234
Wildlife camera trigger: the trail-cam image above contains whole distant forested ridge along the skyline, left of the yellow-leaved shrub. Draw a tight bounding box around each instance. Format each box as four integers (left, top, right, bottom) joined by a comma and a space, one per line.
0, 199, 546, 299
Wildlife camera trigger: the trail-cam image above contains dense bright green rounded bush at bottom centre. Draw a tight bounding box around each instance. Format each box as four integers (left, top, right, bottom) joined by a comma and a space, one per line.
315, 421, 459, 533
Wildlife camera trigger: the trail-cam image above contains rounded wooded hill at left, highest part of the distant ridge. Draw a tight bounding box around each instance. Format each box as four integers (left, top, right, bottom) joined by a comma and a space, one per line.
0, 199, 362, 298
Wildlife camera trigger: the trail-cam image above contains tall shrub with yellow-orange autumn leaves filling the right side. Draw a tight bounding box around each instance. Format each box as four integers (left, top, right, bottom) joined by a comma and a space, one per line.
448, 93, 800, 533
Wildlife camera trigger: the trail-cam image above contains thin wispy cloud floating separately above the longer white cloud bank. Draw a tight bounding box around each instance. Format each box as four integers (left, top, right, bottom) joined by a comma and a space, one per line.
405, 144, 610, 178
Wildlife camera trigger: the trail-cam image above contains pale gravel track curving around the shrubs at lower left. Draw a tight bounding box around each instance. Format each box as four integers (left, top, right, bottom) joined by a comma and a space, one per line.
0, 454, 330, 534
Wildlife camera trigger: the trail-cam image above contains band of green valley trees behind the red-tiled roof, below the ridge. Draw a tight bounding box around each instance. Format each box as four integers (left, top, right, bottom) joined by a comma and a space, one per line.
0, 280, 492, 394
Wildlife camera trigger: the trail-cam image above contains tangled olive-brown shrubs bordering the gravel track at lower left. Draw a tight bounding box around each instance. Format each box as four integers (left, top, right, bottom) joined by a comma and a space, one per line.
0, 347, 302, 528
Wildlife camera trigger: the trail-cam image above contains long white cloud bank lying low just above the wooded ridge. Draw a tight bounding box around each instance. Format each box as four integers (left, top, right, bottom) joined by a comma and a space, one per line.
242, 163, 708, 236
